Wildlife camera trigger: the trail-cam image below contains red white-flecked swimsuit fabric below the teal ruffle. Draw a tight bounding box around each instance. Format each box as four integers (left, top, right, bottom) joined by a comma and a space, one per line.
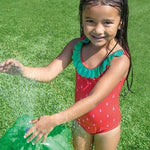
75, 71, 123, 134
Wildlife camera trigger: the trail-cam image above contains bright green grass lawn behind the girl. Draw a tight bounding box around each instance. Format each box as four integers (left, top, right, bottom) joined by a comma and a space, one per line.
0, 0, 150, 150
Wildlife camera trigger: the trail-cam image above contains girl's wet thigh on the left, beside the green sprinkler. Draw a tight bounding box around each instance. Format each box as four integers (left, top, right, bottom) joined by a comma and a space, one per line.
72, 121, 93, 150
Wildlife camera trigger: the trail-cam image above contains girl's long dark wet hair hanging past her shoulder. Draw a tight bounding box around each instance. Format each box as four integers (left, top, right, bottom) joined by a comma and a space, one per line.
79, 0, 133, 94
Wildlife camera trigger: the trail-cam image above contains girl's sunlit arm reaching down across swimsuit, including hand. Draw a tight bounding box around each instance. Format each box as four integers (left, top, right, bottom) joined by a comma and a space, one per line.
25, 55, 130, 143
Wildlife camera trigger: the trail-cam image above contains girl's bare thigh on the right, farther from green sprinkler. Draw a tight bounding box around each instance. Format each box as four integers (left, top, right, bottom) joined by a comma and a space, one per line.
94, 126, 120, 150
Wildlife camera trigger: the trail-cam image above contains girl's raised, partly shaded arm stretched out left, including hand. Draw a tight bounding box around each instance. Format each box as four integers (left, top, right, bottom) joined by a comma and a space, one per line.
0, 39, 79, 82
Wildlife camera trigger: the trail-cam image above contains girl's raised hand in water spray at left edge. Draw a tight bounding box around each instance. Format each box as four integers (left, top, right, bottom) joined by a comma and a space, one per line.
0, 59, 24, 75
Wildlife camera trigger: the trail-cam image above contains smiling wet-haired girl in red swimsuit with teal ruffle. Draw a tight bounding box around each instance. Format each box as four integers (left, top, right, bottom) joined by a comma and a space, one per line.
0, 0, 131, 150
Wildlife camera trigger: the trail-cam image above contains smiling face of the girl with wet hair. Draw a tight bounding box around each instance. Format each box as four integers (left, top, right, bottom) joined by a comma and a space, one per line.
82, 5, 120, 47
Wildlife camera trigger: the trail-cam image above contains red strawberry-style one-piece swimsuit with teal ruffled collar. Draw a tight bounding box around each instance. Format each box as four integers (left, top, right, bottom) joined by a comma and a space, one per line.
72, 38, 125, 134
